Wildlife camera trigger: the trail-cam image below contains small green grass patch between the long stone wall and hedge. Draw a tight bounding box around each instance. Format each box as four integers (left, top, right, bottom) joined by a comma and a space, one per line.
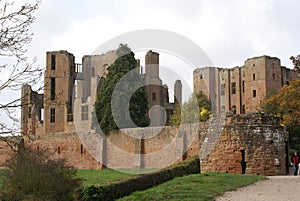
77, 169, 135, 187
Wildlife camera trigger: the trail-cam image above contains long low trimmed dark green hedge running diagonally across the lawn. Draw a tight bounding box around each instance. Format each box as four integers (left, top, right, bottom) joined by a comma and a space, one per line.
81, 157, 200, 201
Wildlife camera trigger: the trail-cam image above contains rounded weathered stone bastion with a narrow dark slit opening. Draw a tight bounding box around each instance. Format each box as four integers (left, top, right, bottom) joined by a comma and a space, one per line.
200, 114, 288, 175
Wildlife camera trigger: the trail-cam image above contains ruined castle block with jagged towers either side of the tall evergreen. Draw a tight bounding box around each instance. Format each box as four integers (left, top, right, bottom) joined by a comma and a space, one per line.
21, 50, 182, 135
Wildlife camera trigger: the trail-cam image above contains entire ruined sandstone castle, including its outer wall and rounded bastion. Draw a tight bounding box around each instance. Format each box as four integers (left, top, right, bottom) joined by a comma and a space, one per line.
11, 51, 299, 175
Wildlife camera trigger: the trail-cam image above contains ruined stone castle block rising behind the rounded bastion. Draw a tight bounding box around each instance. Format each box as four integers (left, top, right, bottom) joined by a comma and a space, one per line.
193, 56, 300, 114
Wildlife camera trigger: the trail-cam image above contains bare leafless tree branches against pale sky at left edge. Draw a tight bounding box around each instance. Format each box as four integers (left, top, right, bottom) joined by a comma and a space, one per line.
0, 0, 42, 146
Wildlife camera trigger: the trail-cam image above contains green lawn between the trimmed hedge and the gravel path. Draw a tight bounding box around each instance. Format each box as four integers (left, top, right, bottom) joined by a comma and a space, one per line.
119, 173, 265, 201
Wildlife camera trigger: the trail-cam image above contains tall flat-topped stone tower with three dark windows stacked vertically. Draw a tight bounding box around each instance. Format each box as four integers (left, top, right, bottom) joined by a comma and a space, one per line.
44, 51, 76, 133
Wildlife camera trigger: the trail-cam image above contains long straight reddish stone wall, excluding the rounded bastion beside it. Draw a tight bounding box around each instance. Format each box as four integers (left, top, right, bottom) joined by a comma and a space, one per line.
18, 124, 205, 169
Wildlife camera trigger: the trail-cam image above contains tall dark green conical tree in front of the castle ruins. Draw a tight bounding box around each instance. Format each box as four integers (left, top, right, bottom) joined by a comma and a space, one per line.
92, 44, 149, 134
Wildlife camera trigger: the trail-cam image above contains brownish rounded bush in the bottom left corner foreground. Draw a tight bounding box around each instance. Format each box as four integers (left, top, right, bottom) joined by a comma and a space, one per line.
1, 147, 81, 201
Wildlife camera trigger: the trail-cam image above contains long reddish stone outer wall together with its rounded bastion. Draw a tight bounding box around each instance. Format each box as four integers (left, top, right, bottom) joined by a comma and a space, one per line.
0, 114, 289, 175
